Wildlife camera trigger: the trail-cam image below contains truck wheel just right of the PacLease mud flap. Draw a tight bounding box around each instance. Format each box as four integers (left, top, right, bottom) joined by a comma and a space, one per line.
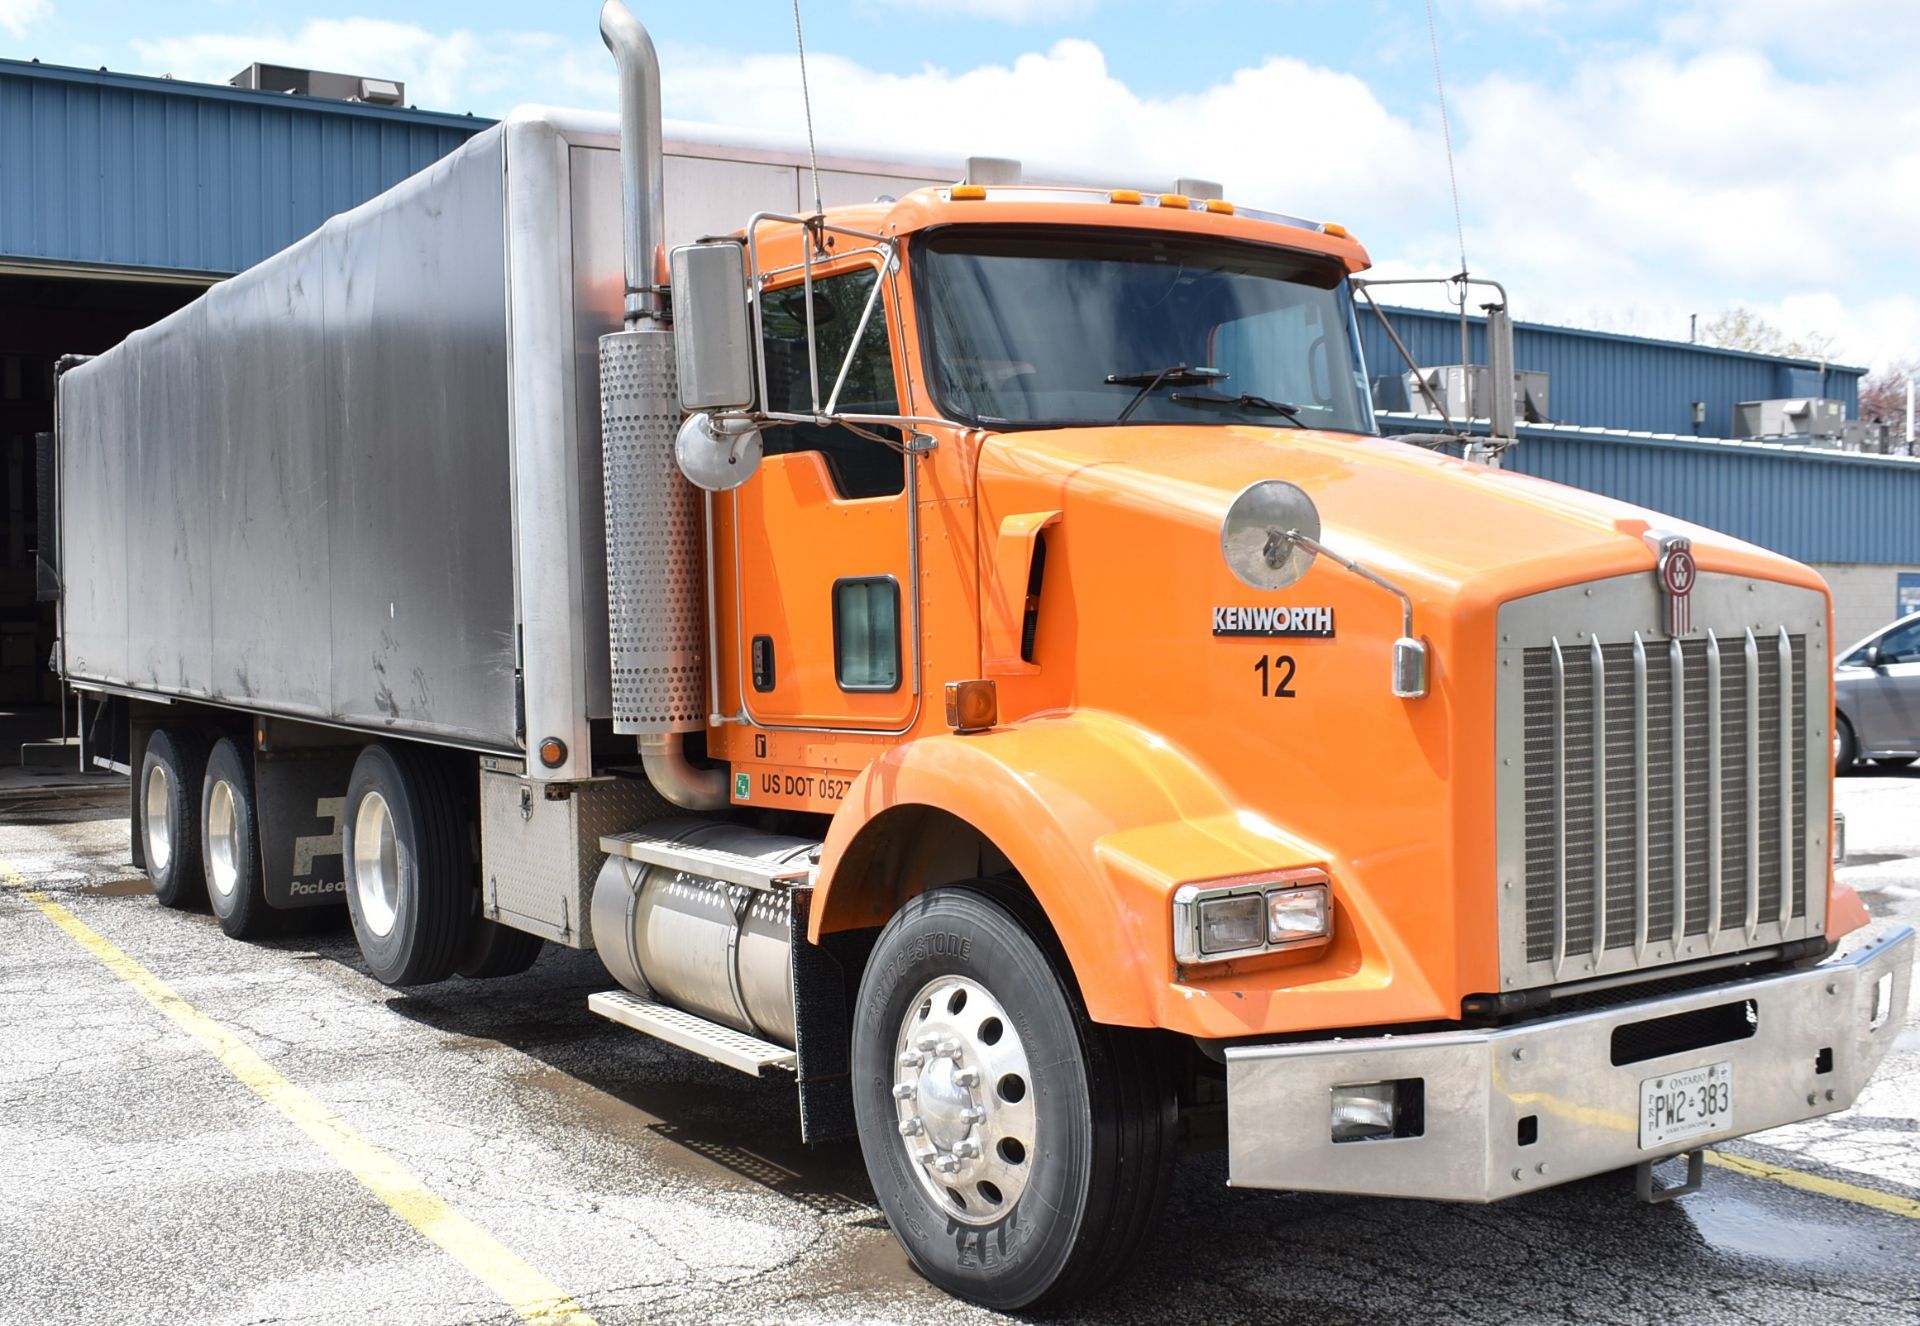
342, 743, 472, 984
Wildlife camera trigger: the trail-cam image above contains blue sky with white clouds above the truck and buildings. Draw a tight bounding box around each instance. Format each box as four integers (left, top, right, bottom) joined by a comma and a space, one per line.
11, 0, 1920, 367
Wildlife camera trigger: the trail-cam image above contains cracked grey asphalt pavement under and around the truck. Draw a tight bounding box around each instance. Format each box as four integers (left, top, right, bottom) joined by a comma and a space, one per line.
0, 770, 1920, 1326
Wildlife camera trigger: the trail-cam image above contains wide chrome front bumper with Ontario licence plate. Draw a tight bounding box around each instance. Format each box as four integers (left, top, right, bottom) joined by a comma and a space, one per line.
1227, 927, 1914, 1201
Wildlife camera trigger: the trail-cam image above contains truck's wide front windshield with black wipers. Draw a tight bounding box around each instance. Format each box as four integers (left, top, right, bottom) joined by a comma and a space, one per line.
914, 226, 1373, 432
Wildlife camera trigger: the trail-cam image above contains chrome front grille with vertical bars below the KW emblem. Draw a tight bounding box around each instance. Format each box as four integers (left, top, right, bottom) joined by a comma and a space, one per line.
1500, 576, 1828, 986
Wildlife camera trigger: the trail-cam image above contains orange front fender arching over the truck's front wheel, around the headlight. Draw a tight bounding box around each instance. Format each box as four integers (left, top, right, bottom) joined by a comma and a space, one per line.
810, 710, 1436, 1036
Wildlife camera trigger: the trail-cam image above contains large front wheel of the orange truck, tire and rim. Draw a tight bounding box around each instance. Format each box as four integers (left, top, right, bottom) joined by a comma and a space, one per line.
852, 885, 1175, 1311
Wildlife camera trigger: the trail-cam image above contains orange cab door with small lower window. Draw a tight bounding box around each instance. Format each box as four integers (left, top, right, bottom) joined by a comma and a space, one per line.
732, 265, 920, 731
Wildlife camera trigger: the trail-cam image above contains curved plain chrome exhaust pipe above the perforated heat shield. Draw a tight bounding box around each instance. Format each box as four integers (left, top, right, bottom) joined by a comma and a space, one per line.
601, 0, 666, 328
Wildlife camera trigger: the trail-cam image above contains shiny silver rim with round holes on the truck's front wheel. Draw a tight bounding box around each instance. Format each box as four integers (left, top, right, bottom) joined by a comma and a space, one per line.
893, 977, 1039, 1224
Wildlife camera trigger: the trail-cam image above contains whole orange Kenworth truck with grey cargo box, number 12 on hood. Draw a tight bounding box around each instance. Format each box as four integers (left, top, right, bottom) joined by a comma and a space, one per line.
45, 0, 1914, 1307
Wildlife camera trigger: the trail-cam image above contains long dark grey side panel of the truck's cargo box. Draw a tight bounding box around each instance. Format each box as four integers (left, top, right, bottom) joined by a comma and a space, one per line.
60, 134, 518, 748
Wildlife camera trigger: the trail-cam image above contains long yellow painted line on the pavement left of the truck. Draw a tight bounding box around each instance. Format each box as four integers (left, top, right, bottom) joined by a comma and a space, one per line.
0, 860, 597, 1326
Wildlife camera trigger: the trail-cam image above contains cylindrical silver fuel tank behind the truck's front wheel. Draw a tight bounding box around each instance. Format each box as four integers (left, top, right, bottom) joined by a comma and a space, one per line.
593, 819, 820, 1048
